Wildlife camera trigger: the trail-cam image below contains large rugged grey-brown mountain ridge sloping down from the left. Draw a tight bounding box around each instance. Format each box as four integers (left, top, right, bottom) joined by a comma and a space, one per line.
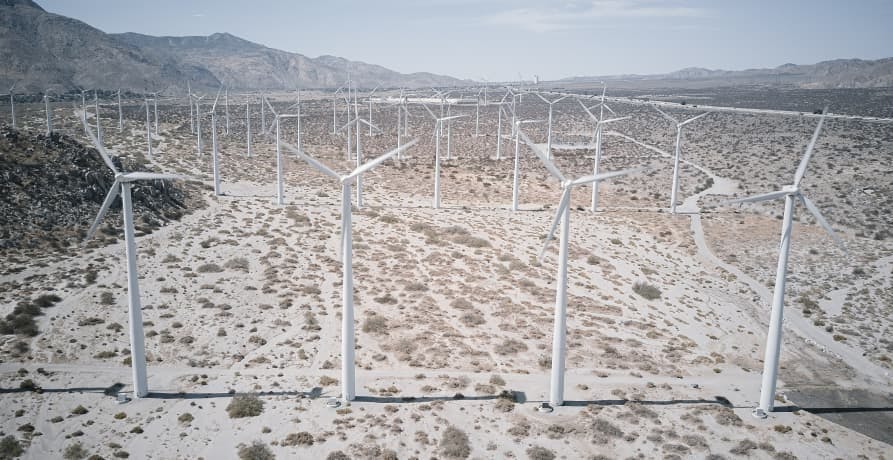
0, 0, 468, 92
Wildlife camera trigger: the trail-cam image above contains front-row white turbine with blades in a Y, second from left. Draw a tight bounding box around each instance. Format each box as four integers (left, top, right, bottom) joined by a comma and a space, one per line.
284, 139, 416, 402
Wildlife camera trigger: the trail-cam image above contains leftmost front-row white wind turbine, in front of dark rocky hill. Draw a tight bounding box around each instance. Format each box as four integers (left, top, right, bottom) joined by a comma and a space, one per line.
84, 116, 183, 398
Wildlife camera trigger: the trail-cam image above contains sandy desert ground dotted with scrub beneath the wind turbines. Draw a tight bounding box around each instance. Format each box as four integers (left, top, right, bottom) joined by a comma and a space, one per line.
0, 85, 893, 459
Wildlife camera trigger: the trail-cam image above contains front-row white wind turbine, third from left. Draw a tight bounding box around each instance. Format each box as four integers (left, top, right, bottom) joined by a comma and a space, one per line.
519, 129, 644, 407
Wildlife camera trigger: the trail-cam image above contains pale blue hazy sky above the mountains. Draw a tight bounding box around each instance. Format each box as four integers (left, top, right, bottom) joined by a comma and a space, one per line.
37, 0, 893, 81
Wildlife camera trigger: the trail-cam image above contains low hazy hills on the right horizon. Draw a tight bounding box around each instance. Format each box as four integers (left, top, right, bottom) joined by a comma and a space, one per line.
559, 58, 893, 89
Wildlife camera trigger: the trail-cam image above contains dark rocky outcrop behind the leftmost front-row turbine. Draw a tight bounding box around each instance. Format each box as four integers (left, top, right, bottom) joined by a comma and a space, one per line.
0, 127, 195, 251
